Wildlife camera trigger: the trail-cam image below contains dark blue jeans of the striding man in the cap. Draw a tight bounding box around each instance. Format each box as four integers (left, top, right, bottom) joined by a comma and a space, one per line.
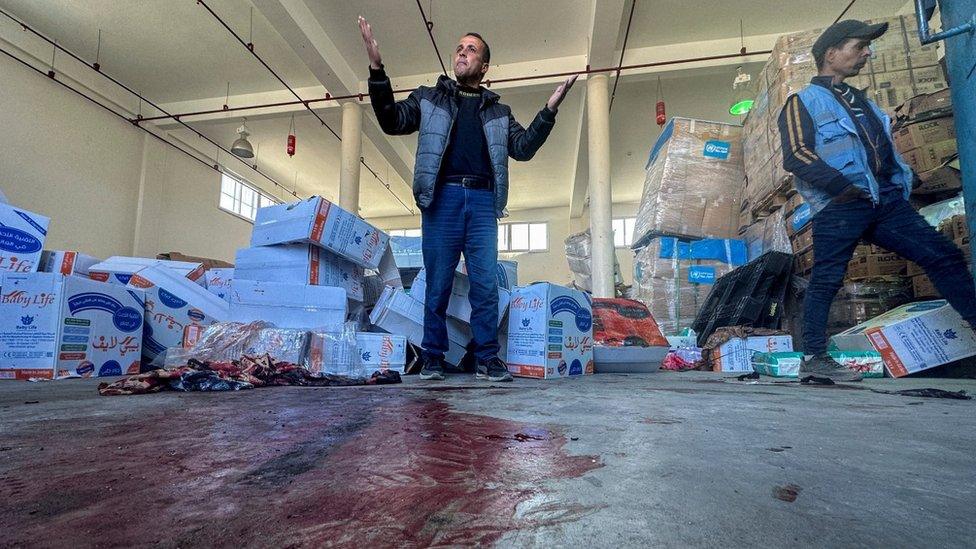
803, 194, 976, 354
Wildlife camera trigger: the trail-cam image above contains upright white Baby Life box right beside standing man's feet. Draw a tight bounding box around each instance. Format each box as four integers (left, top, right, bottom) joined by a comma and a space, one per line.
507, 282, 593, 379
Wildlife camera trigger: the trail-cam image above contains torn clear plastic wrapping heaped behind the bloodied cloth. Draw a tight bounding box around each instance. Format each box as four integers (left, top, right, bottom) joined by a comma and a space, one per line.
161, 321, 308, 368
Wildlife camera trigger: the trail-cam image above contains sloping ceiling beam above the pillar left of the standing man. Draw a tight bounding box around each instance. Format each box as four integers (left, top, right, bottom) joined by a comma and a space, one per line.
254, 0, 414, 197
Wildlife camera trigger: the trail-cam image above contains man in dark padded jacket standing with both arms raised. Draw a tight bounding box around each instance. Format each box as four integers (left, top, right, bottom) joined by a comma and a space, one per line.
359, 17, 576, 382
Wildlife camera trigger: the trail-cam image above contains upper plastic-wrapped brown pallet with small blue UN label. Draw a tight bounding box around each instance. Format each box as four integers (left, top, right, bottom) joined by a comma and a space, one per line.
634, 118, 744, 248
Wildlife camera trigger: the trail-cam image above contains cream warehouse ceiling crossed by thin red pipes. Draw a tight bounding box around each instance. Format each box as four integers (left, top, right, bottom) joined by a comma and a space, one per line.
0, 0, 905, 217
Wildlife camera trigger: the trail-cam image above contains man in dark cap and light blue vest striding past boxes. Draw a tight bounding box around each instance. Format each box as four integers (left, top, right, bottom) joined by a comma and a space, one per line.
779, 20, 976, 383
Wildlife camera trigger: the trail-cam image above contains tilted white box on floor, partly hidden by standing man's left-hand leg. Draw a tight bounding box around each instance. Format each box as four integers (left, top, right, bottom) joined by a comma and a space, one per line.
369, 286, 471, 366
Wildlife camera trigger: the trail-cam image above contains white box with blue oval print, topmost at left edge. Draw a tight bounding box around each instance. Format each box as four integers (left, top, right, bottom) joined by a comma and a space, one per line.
0, 204, 50, 273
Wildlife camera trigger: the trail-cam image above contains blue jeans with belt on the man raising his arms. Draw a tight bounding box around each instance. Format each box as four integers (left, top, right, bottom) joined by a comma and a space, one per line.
421, 184, 499, 360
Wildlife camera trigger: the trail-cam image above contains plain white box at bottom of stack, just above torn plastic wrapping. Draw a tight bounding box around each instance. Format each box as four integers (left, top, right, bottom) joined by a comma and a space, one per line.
228, 278, 347, 331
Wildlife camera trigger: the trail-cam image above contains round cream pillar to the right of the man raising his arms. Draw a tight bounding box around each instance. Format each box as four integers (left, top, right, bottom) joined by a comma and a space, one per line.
586, 74, 614, 297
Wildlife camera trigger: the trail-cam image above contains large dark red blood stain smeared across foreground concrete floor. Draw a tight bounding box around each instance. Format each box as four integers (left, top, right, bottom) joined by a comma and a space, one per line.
0, 389, 603, 547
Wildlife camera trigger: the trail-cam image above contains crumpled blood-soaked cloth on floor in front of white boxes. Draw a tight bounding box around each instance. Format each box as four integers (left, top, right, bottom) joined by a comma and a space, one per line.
98, 355, 402, 396
